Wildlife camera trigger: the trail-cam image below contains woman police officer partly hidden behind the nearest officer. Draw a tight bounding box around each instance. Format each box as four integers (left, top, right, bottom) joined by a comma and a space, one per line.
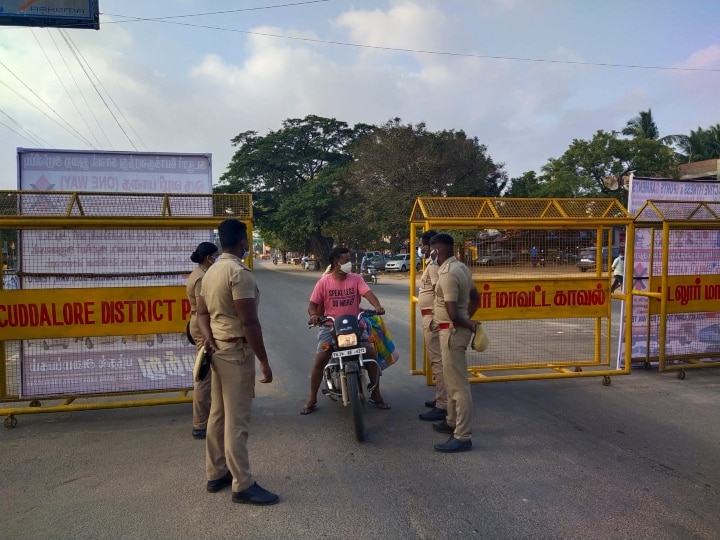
186, 242, 218, 439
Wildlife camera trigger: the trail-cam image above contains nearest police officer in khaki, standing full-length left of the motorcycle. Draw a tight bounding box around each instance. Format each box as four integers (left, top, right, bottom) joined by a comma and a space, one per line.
197, 219, 278, 505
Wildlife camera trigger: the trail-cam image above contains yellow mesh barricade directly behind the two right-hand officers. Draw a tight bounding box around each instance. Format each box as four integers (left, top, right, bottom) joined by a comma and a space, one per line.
410, 197, 632, 385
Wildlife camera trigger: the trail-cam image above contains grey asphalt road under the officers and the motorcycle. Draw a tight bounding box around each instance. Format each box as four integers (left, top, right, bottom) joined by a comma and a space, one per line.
0, 262, 720, 540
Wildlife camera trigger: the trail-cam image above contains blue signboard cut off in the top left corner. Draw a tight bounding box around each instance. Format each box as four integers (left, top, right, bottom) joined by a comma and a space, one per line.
0, 0, 100, 30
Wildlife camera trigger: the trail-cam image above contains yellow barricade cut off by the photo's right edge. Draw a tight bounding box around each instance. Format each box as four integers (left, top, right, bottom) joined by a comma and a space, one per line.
631, 200, 720, 378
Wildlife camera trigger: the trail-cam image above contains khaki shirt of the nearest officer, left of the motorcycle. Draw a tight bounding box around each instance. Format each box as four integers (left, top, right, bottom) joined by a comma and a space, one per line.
200, 253, 260, 341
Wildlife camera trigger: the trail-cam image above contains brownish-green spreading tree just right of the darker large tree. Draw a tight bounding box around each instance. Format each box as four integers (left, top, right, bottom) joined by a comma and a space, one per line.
348, 118, 507, 249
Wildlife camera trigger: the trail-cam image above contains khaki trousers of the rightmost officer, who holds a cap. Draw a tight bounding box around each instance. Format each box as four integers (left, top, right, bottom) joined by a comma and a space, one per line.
440, 326, 473, 441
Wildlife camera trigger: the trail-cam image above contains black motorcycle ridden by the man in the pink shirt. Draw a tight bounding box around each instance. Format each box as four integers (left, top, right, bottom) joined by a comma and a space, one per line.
310, 310, 380, 442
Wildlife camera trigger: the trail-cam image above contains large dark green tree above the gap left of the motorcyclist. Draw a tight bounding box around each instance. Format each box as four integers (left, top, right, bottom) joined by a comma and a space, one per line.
215, 115, 370, 261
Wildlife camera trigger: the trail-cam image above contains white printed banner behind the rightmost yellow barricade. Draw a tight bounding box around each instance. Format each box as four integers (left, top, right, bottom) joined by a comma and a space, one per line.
618, 178, 720, 367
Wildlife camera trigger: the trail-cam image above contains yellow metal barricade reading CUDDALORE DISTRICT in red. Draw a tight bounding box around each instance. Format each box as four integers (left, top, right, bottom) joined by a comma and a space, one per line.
0, 191, 253, 427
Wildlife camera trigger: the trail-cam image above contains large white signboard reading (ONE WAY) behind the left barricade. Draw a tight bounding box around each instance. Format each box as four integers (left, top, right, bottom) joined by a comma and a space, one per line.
18, 148, 213, 397
